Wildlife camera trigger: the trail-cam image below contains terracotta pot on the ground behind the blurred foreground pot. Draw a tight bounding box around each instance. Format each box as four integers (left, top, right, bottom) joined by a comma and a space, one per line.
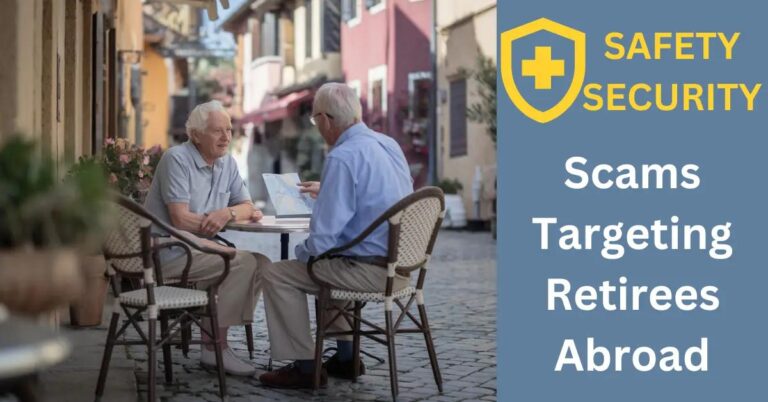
69, 255, 109, 327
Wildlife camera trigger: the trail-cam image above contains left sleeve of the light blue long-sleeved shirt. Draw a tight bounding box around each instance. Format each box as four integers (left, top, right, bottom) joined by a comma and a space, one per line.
295, 158, 357, 262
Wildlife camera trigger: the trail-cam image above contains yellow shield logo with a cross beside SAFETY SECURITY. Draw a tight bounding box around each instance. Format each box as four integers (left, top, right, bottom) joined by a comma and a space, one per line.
501, 18, 587, 123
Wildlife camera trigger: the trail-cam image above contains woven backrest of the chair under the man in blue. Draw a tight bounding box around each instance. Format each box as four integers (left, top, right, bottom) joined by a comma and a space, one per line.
384, 187, 445, 271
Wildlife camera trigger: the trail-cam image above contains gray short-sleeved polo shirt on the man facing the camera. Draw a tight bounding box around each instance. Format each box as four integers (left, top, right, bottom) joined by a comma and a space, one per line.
144, 141, 251, 261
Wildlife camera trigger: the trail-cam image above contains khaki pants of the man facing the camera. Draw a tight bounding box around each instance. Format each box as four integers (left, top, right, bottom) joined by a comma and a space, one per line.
162, 249, 269, 327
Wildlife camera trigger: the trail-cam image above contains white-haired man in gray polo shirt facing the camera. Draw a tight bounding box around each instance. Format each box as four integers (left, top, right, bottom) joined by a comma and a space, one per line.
145, 101, 269, 375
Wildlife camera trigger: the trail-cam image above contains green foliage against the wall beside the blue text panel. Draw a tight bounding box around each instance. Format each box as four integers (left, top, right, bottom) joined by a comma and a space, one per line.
467, 56, 496, 145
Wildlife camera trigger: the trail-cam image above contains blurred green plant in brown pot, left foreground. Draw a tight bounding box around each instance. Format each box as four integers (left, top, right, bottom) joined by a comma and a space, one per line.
0, 136, 110, 314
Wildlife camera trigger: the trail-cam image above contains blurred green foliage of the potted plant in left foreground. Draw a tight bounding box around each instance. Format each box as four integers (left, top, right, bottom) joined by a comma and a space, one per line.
0, 136, 110, 249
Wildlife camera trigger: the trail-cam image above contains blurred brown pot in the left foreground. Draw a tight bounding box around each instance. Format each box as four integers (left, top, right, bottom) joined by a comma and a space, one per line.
0, 248, 83, 315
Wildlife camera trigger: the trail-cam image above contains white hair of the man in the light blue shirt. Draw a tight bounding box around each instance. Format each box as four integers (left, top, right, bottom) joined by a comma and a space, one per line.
314, 82, 363, 129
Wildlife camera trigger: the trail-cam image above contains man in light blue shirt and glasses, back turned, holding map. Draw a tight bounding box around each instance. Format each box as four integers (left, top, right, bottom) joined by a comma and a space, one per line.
259, 83, 413, 388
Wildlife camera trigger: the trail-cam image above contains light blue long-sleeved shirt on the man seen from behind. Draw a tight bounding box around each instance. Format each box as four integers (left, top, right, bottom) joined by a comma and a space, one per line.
296, 123, 413, 262
